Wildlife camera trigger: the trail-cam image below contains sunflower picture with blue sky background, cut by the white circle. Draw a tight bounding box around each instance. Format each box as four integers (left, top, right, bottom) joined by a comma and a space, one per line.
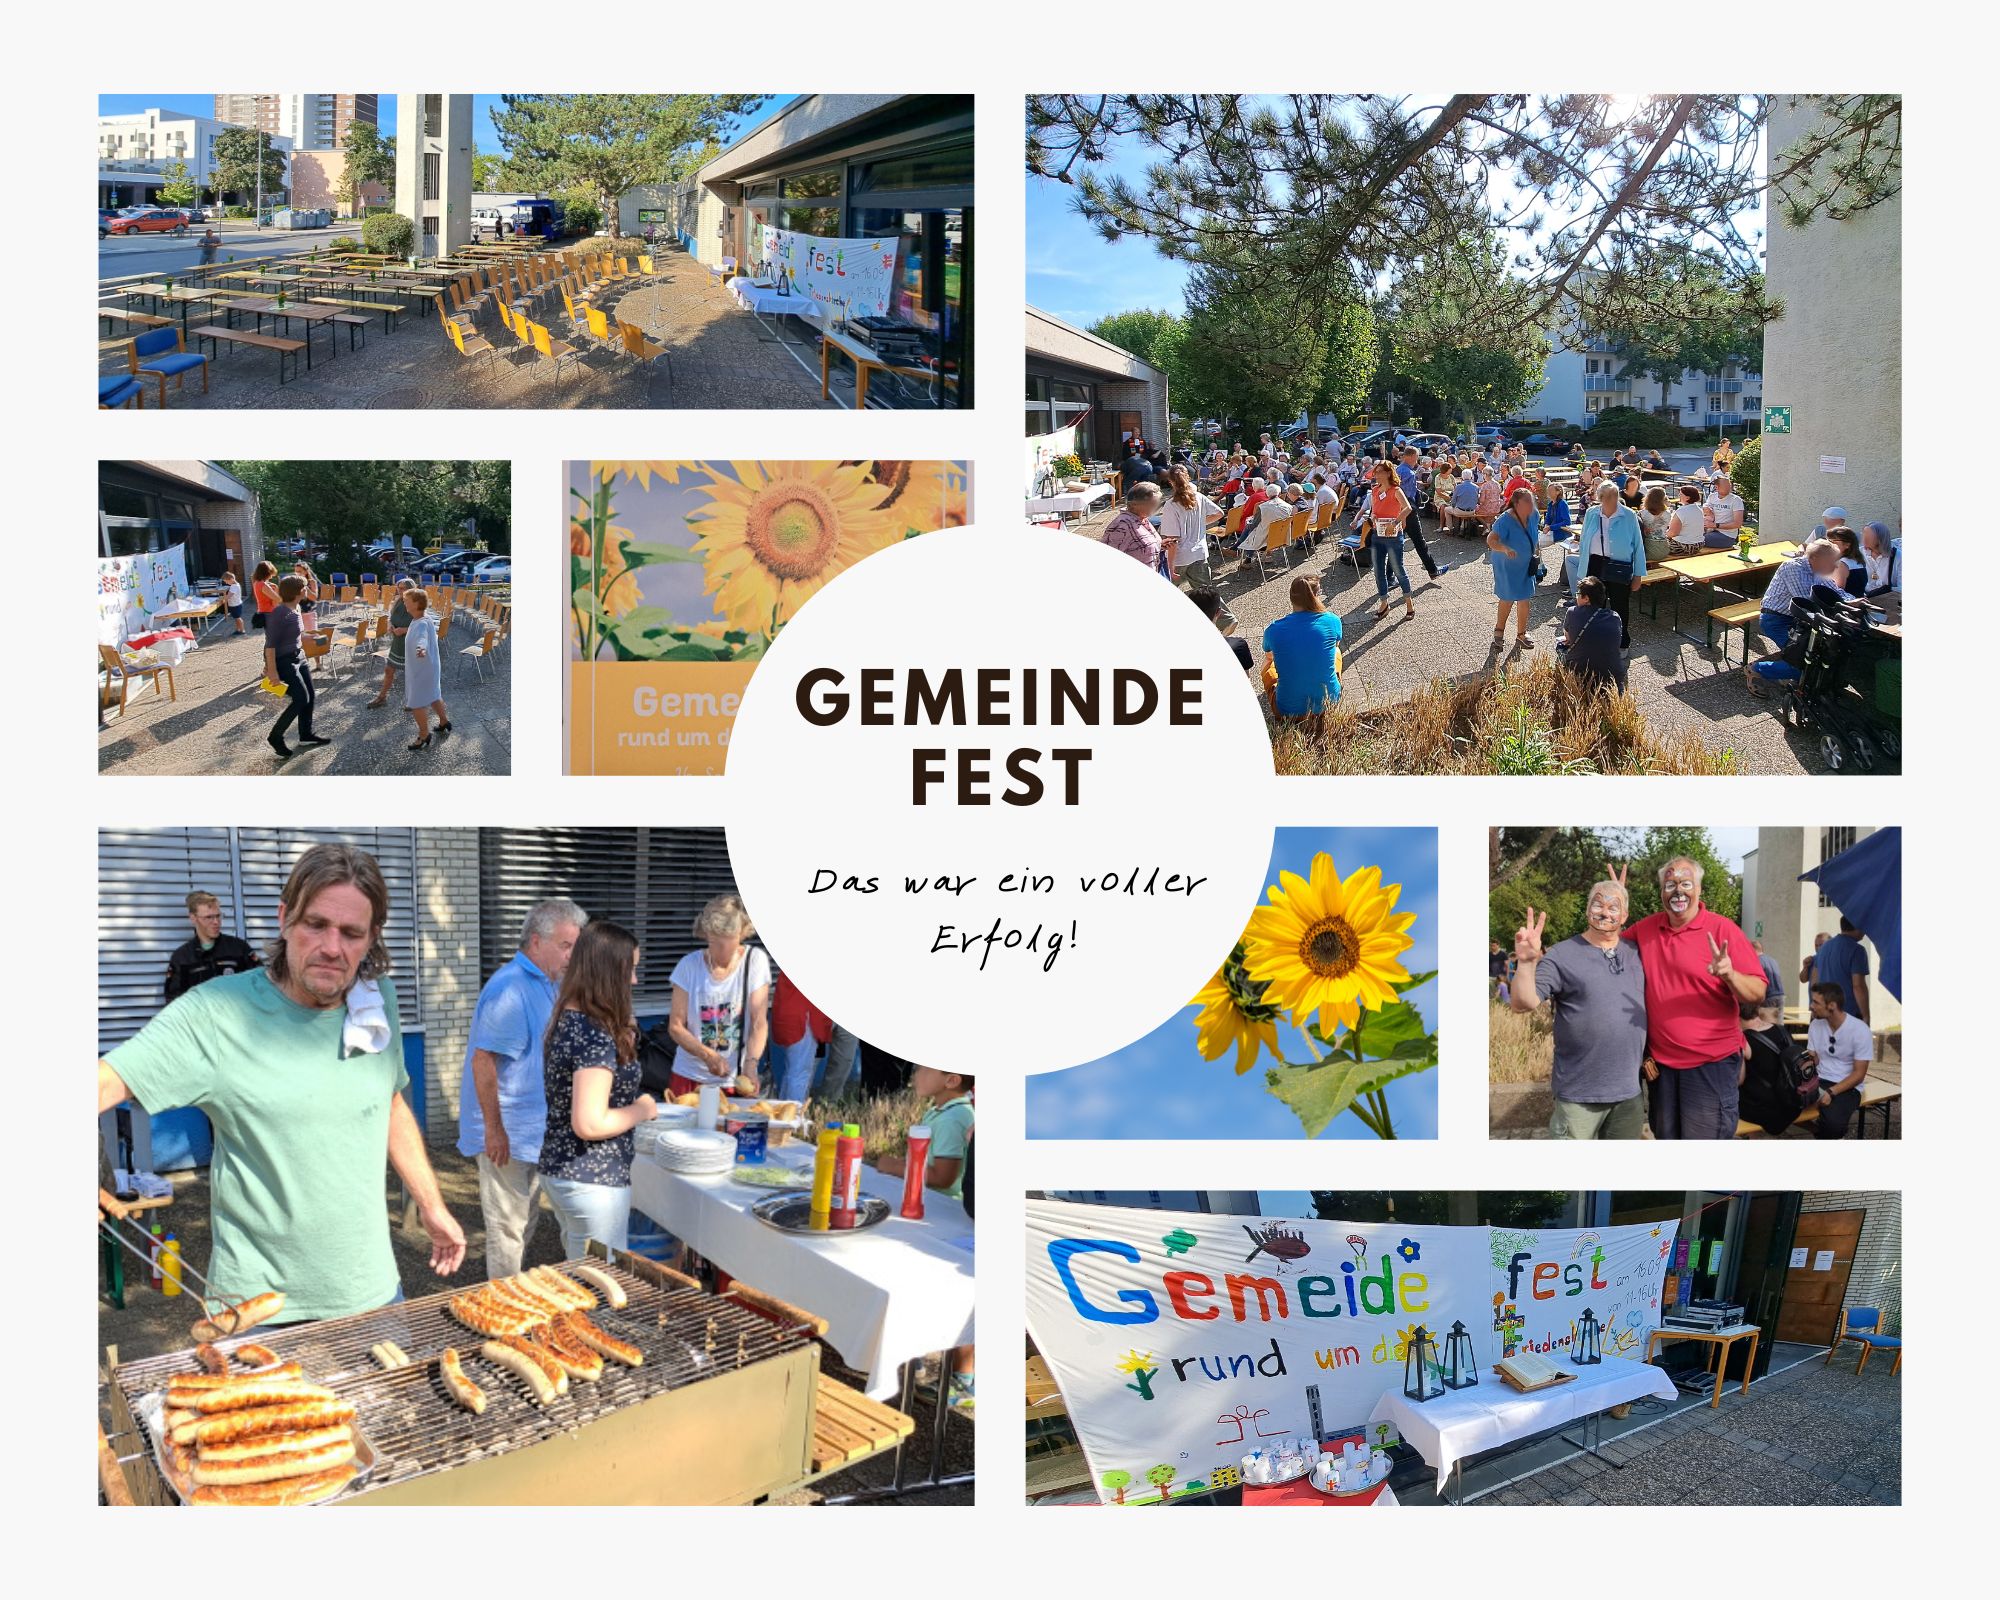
1028, 828, 1438, 1140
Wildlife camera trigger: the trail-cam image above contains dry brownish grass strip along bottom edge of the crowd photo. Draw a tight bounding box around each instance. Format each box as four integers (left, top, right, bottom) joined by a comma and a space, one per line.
1272, 658, 1738, 776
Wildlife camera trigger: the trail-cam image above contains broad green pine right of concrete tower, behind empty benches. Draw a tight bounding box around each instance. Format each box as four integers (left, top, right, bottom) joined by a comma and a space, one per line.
492, 94, 760, 238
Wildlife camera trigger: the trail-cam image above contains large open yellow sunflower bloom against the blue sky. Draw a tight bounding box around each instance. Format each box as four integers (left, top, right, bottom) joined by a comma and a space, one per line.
1244, 850, 1416, 1034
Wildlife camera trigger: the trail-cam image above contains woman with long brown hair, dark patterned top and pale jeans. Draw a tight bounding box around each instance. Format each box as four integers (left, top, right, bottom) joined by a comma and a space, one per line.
536, 922, 658, 1260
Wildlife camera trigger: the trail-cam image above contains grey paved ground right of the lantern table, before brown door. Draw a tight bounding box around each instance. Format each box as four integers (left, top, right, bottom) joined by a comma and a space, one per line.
1480, 1346, 1902, 1506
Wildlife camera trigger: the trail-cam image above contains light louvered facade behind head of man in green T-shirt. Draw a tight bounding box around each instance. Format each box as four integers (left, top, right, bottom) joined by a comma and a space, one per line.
98, 828, 422, 1056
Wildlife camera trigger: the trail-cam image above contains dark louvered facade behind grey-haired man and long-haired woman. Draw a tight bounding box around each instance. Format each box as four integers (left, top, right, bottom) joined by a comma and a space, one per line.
480, 828, 736, 1014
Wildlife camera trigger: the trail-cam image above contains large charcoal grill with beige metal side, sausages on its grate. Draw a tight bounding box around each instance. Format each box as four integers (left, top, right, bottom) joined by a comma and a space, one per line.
99, 1252, 820, 1506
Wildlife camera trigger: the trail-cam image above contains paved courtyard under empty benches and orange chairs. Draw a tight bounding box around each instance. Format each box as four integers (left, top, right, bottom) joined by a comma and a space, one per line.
98, 250, 854, 410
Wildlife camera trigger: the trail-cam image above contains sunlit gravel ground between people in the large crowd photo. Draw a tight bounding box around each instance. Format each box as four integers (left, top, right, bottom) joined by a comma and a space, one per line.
1072, 510, 1880, 774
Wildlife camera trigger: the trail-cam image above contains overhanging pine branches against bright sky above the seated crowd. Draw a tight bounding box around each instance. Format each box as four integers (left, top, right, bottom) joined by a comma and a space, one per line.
1026, 94, 1902, 348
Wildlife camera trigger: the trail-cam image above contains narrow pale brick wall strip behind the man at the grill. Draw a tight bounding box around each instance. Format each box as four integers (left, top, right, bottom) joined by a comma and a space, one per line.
416, 828, 482, 1142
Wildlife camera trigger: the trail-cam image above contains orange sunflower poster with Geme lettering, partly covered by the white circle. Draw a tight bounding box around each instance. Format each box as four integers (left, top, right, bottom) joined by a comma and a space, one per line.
562, 460, 972, 776
